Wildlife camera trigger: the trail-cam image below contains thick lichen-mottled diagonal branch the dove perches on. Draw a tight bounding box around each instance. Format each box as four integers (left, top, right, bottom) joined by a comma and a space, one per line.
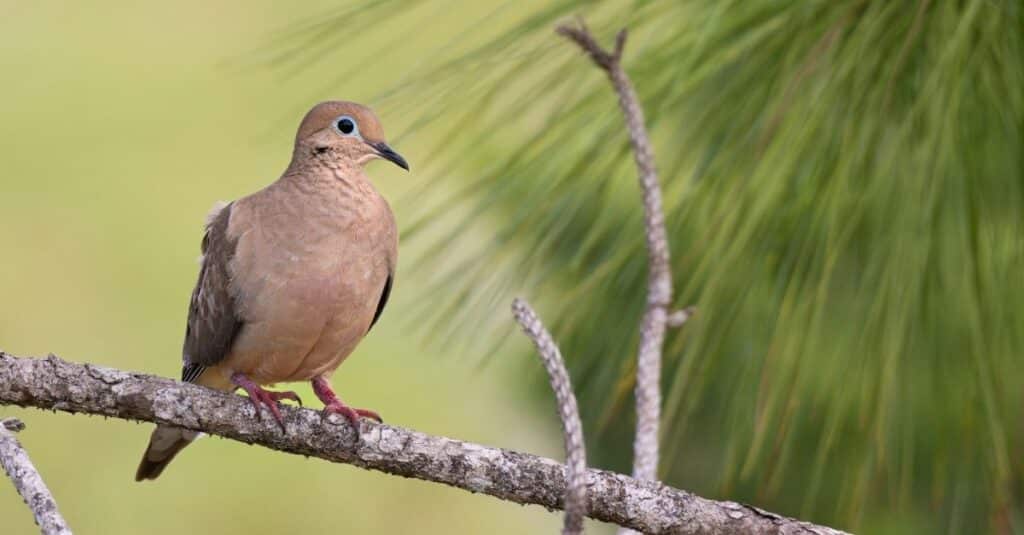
0, 353, 843, 535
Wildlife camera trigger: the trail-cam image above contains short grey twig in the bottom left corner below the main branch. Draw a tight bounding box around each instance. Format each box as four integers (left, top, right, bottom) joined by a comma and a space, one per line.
0, 418, 71, 535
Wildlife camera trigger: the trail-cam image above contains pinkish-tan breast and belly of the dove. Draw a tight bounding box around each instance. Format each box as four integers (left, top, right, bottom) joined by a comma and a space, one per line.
222, 193, 395, 383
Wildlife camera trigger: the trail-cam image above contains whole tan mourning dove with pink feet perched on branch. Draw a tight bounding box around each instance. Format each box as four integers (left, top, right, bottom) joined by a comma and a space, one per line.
135, 100, 409, 481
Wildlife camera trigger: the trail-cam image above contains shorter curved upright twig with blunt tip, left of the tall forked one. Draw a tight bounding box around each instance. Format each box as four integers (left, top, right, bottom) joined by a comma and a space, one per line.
512, 298, 587, 535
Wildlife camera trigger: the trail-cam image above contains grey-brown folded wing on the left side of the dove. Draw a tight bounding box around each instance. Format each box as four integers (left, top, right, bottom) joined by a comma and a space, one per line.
181, 204, 243, 382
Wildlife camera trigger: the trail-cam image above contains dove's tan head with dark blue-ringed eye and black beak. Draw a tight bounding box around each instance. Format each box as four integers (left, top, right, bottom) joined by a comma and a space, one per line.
294, 100, 409, 171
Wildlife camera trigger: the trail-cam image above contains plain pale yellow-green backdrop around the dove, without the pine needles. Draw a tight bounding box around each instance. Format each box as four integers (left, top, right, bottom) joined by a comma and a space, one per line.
0, 1, 589, 535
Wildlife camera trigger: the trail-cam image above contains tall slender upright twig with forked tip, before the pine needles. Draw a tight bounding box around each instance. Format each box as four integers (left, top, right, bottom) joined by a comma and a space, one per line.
556, 20, 672, 491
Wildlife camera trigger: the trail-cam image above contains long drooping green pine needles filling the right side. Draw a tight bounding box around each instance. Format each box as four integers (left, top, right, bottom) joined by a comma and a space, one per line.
337, 0, 1024, 532
